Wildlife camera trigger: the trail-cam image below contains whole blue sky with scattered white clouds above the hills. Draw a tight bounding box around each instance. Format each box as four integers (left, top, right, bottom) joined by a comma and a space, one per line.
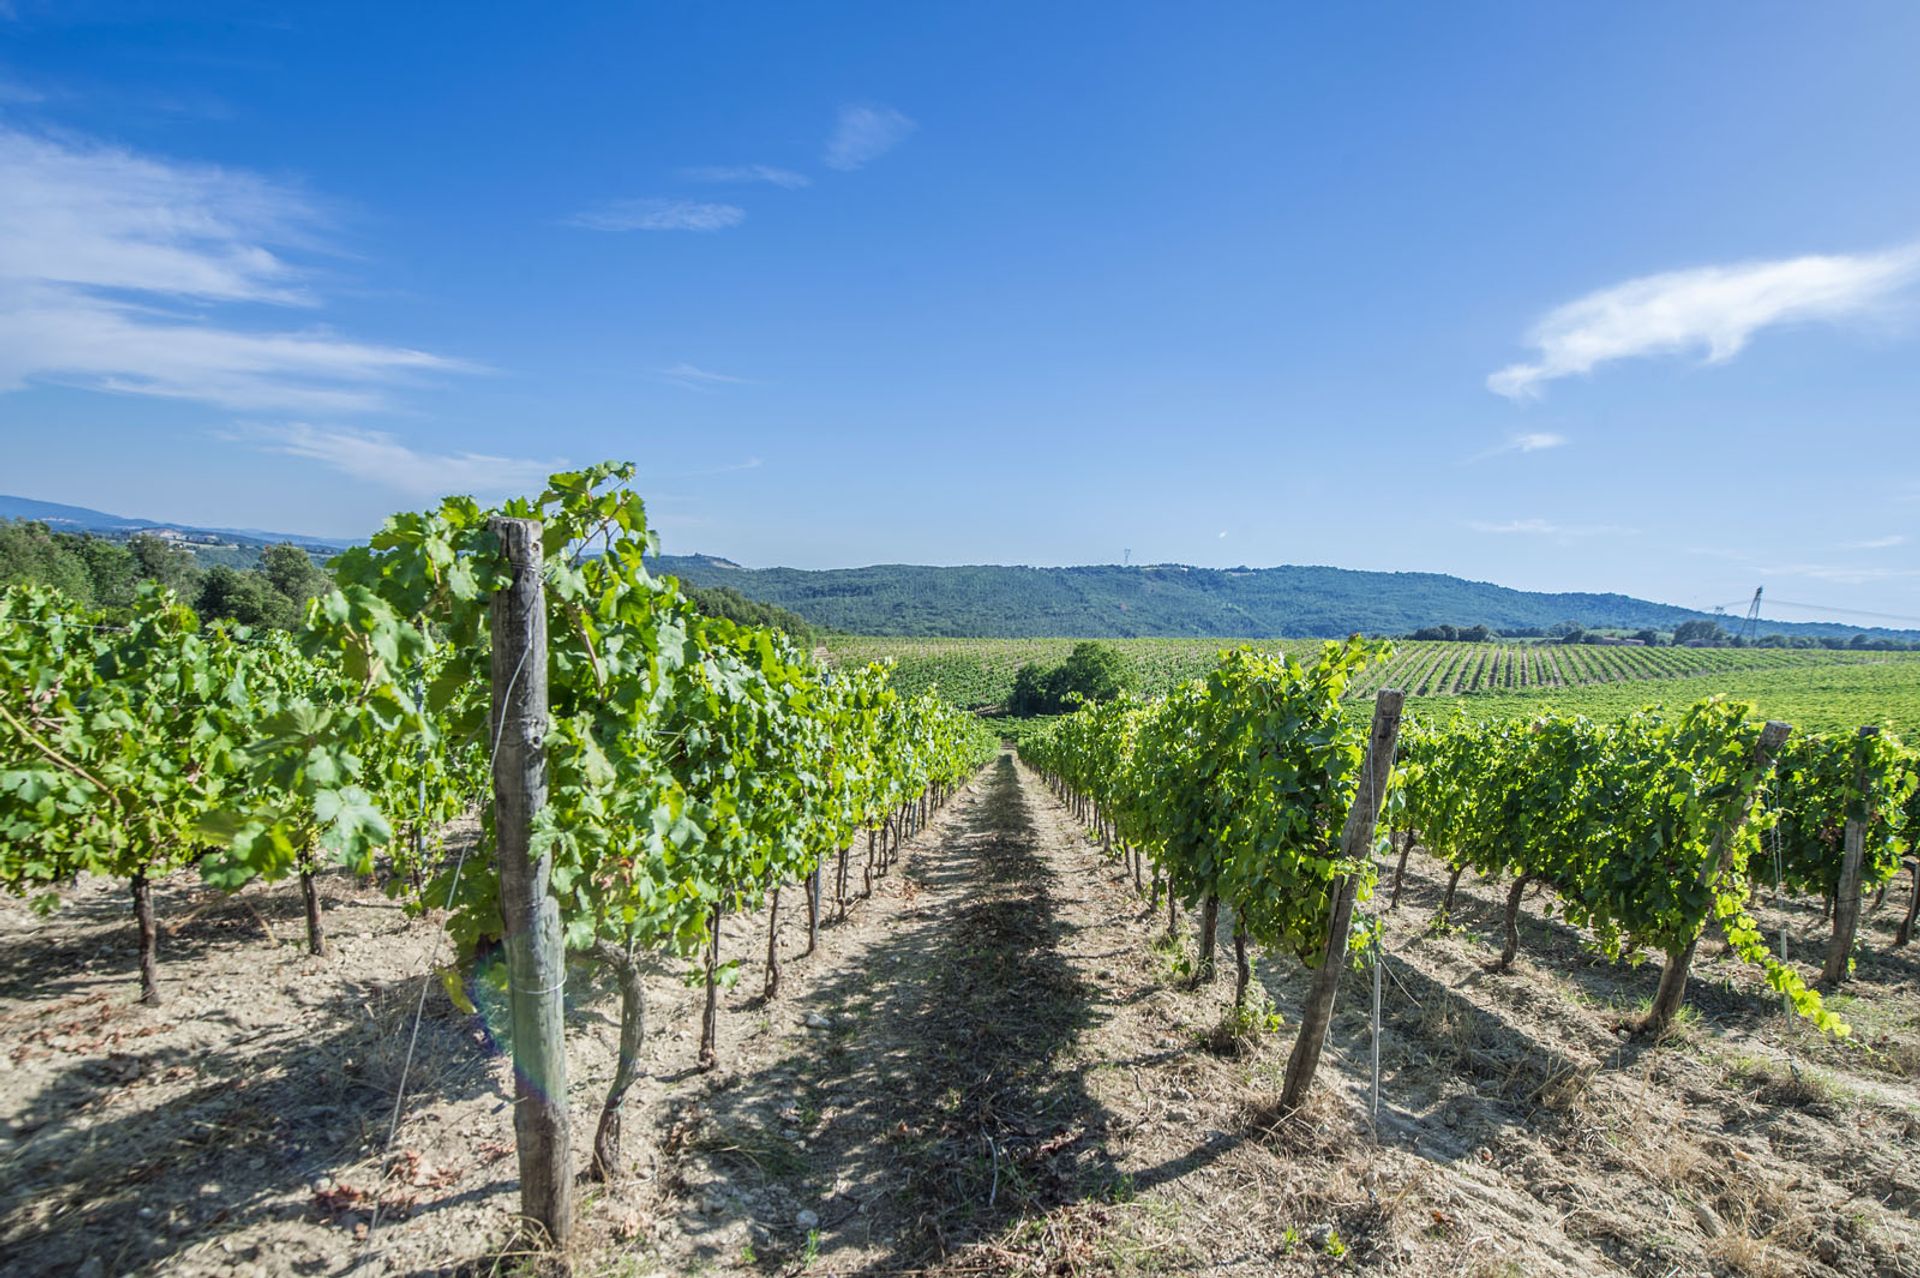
0, 0, 1920, 620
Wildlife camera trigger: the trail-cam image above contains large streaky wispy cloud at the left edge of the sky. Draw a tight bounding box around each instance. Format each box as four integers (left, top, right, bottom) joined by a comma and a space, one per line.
0, 129, 470, 413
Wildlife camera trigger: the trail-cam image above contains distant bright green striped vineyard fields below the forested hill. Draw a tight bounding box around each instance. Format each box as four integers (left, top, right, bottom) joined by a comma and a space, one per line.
828, 637, 1920, 735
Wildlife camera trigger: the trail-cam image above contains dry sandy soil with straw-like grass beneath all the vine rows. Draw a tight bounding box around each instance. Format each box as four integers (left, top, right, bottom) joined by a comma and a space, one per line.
0, 756, 1920, 1278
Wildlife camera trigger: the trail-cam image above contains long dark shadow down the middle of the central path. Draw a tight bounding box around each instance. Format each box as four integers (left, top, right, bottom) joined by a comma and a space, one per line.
660, 756, 1117, 1272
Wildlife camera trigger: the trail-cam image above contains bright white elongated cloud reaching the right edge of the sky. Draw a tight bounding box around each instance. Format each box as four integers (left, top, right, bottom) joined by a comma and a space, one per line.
1486, 248, 1920, 399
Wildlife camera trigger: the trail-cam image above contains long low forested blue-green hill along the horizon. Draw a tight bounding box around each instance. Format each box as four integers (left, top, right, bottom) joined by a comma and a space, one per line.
657, 555, 1914, 639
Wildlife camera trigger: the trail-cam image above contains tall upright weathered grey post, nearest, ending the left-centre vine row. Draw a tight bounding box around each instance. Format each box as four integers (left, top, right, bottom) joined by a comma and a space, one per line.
488, 516, 574, 1247
